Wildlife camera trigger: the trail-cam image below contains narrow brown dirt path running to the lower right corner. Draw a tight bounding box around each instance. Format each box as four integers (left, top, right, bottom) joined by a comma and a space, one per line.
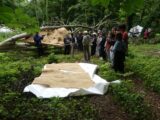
133, 78, 160, 120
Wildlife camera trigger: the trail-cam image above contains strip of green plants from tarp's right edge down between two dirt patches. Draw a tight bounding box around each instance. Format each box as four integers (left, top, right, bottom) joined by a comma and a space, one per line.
92, 54, 154, 120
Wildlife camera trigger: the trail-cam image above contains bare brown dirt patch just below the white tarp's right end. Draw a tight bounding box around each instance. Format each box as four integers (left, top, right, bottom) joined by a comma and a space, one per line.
91, 94, 129, 120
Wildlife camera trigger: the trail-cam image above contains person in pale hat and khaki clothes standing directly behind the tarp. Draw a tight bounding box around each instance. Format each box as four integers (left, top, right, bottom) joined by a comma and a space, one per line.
82, 31, 91, 62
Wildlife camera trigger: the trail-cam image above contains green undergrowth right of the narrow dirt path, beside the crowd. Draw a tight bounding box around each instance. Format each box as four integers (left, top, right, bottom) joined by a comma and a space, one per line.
127, 44, 160, 93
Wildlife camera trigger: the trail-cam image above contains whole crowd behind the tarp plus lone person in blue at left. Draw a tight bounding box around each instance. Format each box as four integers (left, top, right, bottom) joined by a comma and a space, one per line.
34, 24, 128, 73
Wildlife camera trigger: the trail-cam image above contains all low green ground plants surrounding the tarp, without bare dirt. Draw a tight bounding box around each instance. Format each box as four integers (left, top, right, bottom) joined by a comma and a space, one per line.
0, 45, 160, 120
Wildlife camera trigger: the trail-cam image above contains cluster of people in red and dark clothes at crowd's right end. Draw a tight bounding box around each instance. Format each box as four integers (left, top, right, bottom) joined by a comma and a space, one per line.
105, 24, 128, 73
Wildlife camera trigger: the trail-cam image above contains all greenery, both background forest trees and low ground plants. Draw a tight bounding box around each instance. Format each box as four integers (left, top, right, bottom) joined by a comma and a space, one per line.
0, 0, 160, 120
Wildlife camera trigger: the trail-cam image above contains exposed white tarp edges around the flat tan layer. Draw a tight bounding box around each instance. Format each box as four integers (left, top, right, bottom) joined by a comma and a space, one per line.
24, 63, 119, 98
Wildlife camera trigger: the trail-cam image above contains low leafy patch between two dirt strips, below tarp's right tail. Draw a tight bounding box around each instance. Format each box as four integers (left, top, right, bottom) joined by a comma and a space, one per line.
110, 81, 152, 120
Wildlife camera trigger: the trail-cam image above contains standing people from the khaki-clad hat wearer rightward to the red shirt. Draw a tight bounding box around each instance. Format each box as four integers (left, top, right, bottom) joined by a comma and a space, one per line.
72, 24, 128, 73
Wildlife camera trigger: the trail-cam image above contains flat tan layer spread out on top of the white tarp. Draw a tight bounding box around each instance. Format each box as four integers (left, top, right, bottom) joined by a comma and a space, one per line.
33, 63, 94, 88
